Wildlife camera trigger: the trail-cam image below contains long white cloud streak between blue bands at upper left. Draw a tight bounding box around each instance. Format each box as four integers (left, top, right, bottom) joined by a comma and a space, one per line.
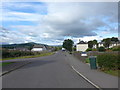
2, 11, 42, 22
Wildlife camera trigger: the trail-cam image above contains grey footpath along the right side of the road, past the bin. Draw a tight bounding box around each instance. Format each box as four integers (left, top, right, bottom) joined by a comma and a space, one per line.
66, 53, 119, 88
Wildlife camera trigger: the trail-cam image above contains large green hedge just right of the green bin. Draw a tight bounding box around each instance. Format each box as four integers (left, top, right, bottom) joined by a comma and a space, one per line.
97, 53, 120, 70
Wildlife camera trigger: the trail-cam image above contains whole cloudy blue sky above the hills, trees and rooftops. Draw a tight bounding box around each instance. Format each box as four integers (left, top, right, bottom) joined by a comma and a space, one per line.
0, 2, 118, 45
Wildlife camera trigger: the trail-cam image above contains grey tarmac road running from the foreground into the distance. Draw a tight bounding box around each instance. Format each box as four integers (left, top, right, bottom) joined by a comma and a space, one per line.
2, 51, 94, 88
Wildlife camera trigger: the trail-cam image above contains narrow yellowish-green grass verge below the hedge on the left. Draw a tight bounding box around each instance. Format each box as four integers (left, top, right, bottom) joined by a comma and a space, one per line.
0, 52, 54, 60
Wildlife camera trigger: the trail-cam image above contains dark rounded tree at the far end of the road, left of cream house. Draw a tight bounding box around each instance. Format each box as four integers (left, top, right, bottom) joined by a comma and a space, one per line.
63, 39, 74, 52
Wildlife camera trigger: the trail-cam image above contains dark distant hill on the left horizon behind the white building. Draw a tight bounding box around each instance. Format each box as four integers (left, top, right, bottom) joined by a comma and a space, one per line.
0, 42, 48, 49
